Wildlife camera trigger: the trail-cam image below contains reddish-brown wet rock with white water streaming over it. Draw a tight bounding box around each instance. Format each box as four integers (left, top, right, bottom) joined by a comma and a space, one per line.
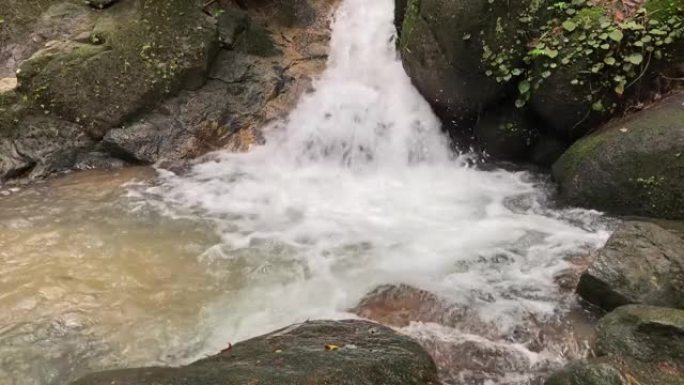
351, 285, 592, 385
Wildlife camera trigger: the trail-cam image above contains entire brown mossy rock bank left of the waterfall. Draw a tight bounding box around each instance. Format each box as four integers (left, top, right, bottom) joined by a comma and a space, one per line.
0, 0, 335, 180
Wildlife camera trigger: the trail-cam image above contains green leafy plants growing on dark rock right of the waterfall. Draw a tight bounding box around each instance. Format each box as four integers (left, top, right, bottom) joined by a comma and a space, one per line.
482, 0, 684, 111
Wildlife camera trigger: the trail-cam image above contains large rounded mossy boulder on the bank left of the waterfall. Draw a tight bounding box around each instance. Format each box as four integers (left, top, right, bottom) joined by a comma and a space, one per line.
18, 0, 218, 137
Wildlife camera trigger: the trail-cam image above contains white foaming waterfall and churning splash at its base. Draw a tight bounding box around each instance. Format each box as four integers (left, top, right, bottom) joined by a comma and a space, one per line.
145, 0, 607, 383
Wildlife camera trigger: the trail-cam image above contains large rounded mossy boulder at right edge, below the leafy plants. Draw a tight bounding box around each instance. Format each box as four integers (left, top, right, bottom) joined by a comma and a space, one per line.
553, 93, 684, 219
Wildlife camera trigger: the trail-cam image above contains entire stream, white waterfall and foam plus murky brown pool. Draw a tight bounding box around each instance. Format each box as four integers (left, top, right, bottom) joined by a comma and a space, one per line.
0, 0, 610, 385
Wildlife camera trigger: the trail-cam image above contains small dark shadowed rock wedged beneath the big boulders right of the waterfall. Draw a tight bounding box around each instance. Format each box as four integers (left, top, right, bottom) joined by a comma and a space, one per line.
473, 105, 539, 161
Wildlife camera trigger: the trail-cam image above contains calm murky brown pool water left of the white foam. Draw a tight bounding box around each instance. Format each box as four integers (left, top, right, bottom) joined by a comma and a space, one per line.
0, 168, 222, 385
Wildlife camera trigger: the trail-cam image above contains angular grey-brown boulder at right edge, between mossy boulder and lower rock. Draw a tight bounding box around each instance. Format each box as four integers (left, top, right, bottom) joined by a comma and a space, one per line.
577, 222, 684, 310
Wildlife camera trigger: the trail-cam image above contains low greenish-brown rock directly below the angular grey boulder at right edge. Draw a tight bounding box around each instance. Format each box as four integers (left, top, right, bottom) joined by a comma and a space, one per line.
596, 305, 684, 364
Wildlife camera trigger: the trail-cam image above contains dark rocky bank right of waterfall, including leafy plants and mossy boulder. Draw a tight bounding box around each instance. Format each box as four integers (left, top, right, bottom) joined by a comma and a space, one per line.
397, 0, 684, 218
